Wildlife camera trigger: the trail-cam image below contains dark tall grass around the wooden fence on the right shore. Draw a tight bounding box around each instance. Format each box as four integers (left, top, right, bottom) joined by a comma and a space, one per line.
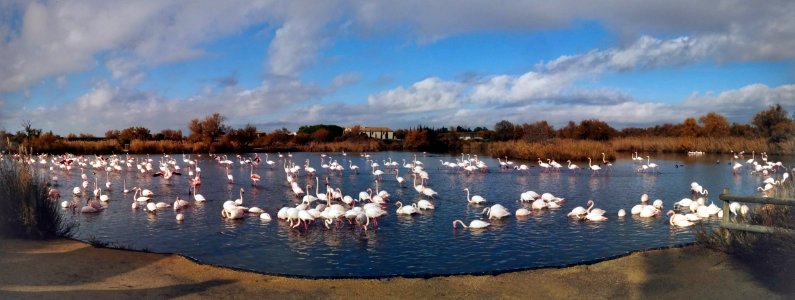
696, 180, 795, 295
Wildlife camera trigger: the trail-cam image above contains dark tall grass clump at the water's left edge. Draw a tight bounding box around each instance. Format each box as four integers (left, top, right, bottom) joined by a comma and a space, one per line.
0, 152, 76, 239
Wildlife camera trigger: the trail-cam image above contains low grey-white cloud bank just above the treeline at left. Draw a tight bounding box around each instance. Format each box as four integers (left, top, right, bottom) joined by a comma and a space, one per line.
7, 80, 326, 135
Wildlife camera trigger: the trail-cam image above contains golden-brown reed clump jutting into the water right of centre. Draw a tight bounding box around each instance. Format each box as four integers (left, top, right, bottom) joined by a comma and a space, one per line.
487, 139, 616, 164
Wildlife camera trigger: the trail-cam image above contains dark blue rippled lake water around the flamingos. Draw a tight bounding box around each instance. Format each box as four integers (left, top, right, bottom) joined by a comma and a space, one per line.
45, 152, 788, 277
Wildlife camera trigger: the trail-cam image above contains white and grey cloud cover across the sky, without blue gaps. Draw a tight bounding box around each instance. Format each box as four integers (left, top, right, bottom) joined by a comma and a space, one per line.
0, 0, 795, 132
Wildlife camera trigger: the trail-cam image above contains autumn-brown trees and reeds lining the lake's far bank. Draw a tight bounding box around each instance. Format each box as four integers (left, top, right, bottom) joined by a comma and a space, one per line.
0, 105, 795, 159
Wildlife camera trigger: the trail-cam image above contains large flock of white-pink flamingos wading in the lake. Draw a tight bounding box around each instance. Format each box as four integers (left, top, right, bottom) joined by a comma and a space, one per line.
12, 152, 789, 236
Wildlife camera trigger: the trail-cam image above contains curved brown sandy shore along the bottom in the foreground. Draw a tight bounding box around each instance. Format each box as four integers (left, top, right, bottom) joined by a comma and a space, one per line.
0, 240, 792, 299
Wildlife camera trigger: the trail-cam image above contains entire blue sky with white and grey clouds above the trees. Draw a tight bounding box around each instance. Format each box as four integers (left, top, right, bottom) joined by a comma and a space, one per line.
0, 0, 795, 136
